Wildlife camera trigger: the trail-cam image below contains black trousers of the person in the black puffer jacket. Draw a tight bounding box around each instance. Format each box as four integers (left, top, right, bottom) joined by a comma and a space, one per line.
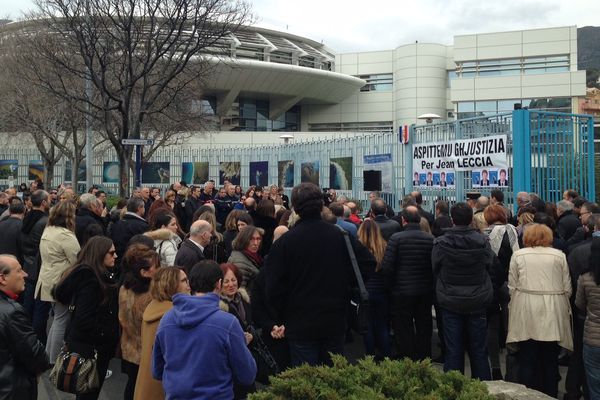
391, 294, 433, 360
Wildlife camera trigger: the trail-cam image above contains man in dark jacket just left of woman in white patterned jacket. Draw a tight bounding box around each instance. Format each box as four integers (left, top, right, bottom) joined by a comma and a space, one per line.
110, 197, 149, 262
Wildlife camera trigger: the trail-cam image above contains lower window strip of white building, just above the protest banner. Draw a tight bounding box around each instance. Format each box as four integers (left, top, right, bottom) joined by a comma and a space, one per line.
456, 97, 571, 119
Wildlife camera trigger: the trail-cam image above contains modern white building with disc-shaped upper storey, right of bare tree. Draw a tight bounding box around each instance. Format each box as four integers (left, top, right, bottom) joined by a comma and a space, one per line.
196, 26, 586, 144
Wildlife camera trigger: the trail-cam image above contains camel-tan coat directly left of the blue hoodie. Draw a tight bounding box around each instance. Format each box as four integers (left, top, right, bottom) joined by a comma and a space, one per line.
133, 300, 173, 400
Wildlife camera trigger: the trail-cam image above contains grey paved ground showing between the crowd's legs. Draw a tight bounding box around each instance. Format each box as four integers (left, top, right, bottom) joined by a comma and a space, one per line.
38, 324, 567, 400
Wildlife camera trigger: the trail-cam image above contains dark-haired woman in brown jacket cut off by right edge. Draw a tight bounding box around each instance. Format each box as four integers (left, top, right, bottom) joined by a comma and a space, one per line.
575, 236, 600, 399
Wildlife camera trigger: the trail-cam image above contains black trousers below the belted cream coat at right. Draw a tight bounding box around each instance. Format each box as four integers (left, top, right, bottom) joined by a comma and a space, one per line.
519, 340, 560, 397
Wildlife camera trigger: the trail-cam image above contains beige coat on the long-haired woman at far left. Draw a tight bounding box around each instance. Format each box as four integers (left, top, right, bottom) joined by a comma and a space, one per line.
35, 226, 80, 301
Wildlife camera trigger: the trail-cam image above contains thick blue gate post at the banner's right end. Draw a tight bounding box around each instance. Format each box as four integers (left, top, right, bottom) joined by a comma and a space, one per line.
512, 110, 531, 212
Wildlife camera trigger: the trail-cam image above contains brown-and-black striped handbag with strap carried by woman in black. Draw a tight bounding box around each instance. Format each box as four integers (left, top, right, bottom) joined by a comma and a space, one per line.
50, 296, 100, 394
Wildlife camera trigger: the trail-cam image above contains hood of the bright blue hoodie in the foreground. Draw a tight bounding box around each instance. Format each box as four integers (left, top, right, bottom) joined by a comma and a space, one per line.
172, 293, 220, 328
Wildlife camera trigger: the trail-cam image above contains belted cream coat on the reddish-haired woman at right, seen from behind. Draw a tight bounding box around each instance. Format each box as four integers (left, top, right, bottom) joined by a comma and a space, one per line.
506, 247, 573, 350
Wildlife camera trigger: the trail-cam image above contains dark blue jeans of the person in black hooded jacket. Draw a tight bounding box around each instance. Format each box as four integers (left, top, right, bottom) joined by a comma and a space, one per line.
442, 309, 492, 381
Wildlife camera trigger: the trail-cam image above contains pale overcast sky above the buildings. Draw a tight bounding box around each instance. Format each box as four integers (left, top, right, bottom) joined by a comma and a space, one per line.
0, 0, 600, 53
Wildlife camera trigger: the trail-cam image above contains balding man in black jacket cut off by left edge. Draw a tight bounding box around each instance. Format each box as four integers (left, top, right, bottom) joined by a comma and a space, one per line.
0, 254, 49, 399
